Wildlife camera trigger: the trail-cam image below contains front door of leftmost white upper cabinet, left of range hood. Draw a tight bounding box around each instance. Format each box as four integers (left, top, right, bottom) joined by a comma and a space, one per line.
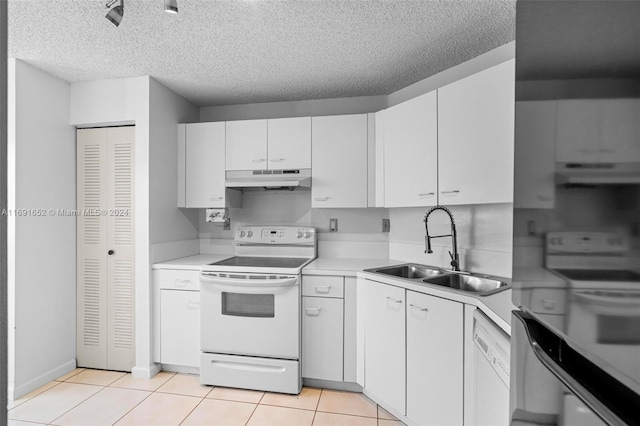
185, 122, 225, 208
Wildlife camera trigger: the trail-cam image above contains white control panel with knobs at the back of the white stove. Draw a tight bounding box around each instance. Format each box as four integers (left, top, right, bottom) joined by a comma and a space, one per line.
234, 226, 316, 245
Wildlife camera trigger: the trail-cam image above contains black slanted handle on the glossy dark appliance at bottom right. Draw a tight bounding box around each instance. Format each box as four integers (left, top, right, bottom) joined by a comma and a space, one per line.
512, 311, 640, 426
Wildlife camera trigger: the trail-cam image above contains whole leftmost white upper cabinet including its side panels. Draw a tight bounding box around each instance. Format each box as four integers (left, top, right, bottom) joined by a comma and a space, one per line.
178, 122, 240, 208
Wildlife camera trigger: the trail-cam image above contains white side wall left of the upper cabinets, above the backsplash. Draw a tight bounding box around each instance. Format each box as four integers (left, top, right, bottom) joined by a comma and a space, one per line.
149, 79, 200, 244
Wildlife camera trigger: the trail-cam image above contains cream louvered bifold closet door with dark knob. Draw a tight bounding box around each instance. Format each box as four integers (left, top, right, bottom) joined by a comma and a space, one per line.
77, 127, 135, 371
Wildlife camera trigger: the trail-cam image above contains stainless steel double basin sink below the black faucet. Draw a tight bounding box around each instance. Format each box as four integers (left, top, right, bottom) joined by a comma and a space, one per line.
366, 263, 511, 296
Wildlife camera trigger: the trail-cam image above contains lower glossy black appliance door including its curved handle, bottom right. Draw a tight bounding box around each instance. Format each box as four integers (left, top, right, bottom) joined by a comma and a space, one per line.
510, 311, 640, 426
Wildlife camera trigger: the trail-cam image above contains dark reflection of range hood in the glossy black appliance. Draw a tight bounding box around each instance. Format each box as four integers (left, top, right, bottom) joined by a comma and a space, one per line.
556, 163, 640, 185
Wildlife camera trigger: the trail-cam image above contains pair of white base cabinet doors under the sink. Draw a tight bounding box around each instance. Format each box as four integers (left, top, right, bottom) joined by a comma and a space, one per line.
358, 278, 464, 426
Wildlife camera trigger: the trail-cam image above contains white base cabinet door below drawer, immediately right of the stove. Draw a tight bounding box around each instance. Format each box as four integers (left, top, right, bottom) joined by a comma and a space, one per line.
302, 297, 344, 382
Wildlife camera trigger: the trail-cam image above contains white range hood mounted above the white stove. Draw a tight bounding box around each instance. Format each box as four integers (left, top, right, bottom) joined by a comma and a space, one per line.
224, 169, 311, 190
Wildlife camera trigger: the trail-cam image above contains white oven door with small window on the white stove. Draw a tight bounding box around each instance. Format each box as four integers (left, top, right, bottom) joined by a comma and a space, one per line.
200, 273, 300, 359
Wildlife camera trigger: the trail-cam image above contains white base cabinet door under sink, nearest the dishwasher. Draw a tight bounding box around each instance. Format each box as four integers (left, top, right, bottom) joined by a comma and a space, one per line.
407, 291, 464, 426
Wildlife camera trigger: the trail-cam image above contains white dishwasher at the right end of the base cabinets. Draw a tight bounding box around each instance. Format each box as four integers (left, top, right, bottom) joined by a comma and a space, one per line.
472, 309, 510, 426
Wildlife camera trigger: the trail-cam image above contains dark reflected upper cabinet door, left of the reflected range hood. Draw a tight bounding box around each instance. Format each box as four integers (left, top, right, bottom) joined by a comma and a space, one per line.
513, 101, 557, 209
